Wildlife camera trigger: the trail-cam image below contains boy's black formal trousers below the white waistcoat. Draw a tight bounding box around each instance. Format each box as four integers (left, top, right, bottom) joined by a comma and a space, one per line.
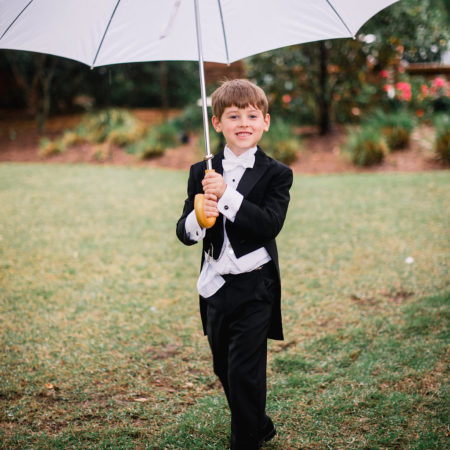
207, 262, 276, 450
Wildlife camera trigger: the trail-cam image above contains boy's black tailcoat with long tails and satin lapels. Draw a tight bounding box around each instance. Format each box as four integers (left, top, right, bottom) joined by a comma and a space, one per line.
177, 147, 293, 340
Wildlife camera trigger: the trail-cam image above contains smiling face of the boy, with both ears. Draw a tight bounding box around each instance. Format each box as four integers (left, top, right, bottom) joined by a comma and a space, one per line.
212, 106, 270, 156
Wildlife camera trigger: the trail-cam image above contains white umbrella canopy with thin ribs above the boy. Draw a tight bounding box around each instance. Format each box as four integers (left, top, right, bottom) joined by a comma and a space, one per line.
0, 0, 397, 66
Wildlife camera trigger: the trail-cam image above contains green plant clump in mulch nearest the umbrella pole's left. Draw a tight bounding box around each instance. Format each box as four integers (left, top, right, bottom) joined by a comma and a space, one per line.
127, 122, 179, 159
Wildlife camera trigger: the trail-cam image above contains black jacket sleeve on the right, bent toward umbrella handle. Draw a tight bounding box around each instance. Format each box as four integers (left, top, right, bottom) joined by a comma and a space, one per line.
233, 163, 293, 241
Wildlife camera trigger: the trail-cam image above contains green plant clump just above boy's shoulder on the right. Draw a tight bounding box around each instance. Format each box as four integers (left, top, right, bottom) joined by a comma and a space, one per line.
261, 120, 301, 164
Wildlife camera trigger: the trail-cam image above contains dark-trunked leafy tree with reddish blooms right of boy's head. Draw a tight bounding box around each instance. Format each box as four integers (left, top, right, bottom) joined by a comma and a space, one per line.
248, 0, 450, 134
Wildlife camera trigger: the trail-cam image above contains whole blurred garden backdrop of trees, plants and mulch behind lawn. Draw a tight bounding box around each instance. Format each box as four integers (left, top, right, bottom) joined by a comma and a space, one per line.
0, 0, 450, 171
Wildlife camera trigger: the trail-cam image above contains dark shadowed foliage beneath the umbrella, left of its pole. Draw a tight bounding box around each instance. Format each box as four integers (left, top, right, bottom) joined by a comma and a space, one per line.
0, 50, 198, 115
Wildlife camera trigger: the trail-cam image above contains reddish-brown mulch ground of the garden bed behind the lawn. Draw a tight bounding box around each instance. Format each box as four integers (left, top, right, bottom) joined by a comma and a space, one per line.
0, 110, 449, 174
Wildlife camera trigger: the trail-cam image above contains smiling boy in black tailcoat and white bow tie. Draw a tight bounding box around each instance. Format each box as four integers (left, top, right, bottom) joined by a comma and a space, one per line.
177, 80, 293, 450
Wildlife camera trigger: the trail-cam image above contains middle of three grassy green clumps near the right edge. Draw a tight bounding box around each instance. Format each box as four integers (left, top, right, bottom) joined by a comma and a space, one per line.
363, 110, 414, 150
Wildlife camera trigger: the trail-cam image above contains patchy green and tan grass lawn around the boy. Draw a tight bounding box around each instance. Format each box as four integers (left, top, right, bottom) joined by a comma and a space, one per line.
0, 164, 450, 449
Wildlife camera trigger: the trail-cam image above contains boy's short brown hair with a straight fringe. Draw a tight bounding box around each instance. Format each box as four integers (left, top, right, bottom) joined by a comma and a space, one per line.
211, 79, 269, 120
